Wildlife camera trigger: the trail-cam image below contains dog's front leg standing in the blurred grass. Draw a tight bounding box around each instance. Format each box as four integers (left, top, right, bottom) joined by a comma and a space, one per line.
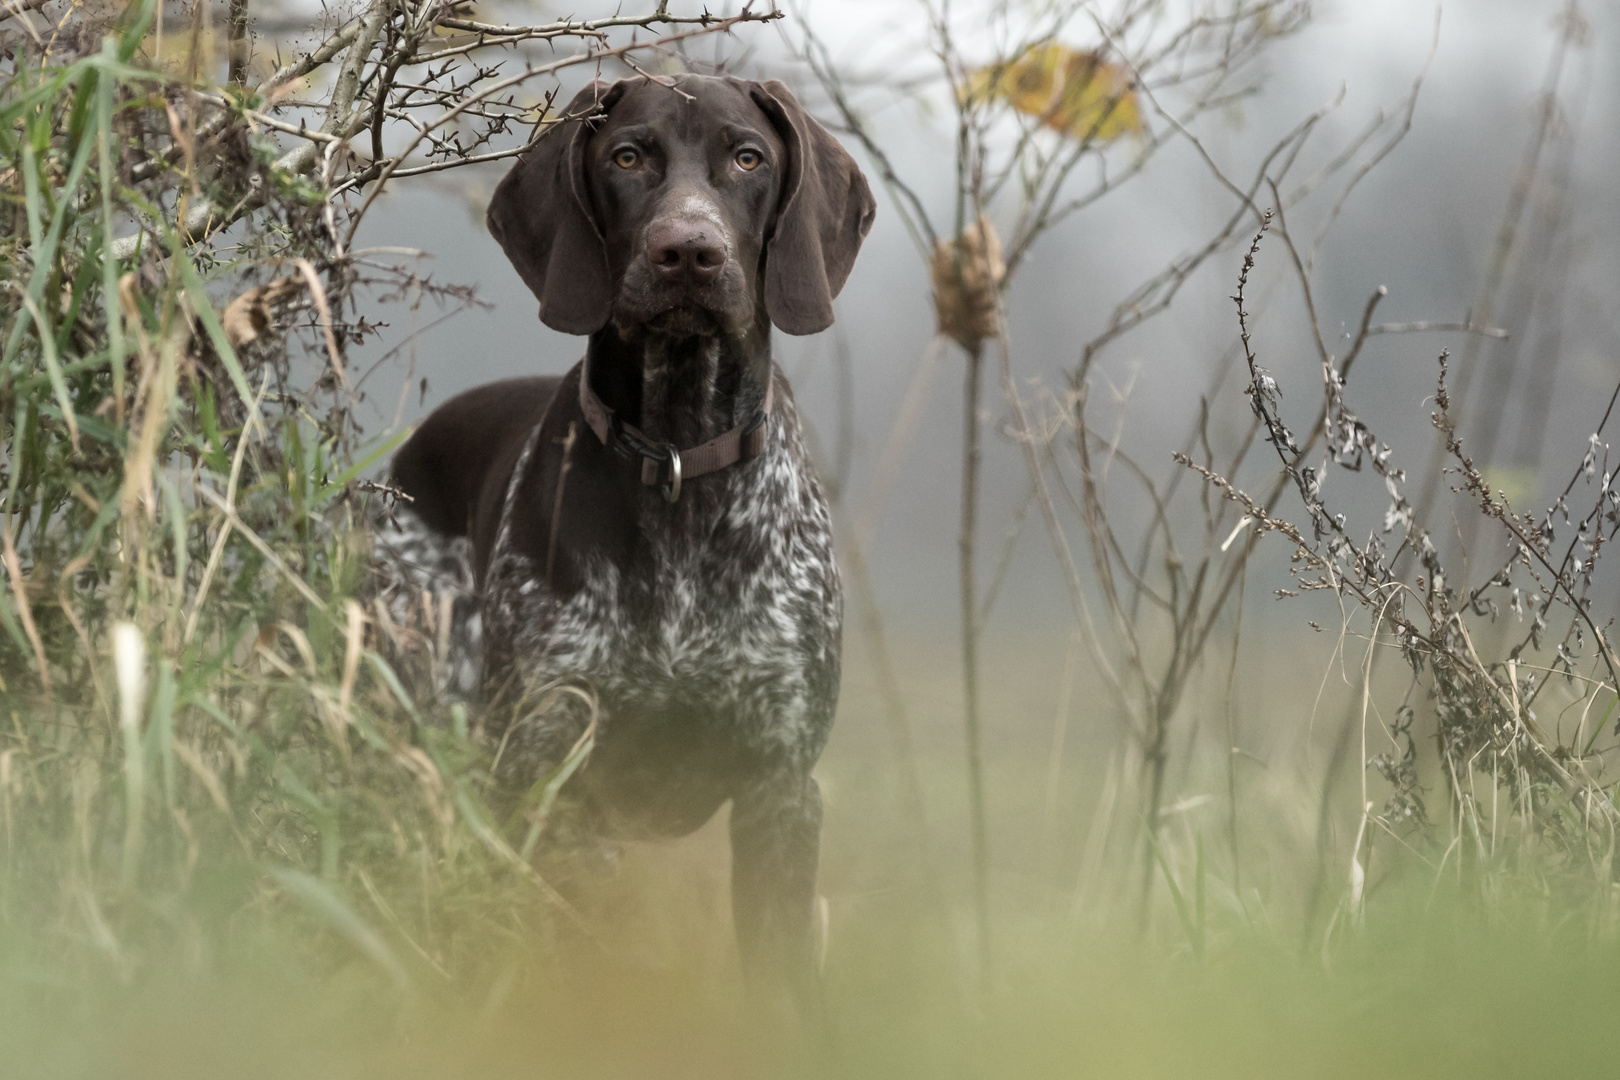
731, 774, 821, 1009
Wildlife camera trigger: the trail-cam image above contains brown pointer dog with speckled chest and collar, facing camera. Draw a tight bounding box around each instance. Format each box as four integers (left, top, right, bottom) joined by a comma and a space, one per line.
377, 74, 875, 994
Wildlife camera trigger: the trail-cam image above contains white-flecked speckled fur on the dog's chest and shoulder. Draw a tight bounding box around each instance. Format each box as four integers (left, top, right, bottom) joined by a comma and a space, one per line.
486, 440, 842, 742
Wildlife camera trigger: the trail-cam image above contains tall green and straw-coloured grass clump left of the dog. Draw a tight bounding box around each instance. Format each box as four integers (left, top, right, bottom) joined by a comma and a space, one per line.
0, 0, 551, 1016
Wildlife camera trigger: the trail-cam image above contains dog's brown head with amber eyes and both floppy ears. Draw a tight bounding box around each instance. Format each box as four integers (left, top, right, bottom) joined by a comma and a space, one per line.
489, 76, 876, 337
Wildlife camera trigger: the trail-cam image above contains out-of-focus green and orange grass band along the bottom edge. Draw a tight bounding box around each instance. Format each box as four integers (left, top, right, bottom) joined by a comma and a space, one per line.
0, 767, 1620, 1078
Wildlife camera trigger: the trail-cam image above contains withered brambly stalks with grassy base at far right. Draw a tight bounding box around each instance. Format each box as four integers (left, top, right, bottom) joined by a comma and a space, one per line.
1176, 215, 1620, 860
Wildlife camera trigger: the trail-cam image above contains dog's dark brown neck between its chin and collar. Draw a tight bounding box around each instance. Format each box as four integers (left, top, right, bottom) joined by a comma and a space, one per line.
588, 321, 771, 449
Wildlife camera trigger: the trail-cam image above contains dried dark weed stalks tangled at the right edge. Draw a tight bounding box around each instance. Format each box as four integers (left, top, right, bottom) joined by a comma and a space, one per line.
1175, 223, 1620, 827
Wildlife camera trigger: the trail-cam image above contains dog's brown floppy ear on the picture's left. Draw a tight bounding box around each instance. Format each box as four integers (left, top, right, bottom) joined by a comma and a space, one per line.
486, 81, 624, 334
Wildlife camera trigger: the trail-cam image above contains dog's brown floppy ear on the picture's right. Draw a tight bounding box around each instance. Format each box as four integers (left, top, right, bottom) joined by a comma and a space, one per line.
750, 79, 878, 334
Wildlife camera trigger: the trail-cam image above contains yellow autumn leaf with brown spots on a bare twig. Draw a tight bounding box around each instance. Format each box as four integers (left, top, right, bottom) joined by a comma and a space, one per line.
961, 42, 1144, 142
